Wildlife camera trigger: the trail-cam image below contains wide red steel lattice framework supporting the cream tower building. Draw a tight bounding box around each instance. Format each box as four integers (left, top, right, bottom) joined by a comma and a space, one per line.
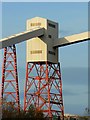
24, 62, 64, 120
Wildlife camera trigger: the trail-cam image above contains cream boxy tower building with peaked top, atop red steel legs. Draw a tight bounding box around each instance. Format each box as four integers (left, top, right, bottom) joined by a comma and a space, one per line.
27, 17, 58, 63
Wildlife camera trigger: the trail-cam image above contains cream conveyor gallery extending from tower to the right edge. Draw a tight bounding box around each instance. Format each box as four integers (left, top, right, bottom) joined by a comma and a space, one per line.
53, 32, 90, 48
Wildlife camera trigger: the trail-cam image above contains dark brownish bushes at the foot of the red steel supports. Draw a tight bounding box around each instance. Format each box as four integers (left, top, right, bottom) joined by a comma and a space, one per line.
2, 102, 48, 120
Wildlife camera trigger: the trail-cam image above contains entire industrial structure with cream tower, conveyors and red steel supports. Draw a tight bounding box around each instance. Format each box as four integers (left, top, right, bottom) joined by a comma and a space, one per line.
0, 17, 90, 120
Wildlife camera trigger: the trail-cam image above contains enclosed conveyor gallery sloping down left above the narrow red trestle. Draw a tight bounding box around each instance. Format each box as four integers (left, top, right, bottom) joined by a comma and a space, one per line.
0, 28, 45, 49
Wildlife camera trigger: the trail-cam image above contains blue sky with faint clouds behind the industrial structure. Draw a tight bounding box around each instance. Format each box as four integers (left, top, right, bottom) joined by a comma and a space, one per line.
0, 2, 88, 115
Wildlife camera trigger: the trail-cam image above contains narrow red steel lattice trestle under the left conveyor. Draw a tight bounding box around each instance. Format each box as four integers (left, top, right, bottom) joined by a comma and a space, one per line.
2, 45, 20, 110
